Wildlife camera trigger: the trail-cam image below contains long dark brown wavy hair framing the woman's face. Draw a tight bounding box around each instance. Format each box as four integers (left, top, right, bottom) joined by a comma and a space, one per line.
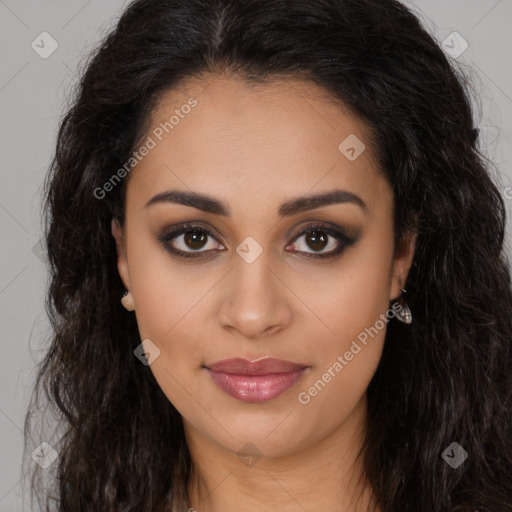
25, 0, 512, 512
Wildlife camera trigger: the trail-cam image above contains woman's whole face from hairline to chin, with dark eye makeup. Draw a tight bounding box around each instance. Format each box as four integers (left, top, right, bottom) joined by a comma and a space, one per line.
113, 76, 414, 457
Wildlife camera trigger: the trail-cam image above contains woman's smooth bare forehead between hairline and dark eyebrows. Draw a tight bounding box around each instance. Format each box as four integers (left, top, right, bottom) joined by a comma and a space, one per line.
128, 75, 390, 215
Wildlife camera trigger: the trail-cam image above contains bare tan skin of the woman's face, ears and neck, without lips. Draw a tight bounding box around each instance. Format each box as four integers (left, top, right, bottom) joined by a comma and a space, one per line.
112, 75, 415, 512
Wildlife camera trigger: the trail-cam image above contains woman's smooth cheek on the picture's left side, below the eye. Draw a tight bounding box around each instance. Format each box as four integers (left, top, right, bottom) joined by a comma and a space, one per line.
128, 224, 218, 384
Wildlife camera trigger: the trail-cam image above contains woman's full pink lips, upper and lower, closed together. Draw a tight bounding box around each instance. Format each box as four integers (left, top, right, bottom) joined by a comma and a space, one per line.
206, 358, 310, 403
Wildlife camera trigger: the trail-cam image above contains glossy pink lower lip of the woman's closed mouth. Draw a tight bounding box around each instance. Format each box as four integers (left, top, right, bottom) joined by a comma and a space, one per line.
207, 368, 308, 403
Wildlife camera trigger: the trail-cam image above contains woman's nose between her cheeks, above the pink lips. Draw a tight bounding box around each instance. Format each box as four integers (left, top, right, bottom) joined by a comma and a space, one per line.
218, 250, 293, 340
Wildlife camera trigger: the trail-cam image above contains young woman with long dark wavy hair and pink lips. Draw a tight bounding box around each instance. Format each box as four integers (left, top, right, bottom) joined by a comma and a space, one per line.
26, 0, 512, 512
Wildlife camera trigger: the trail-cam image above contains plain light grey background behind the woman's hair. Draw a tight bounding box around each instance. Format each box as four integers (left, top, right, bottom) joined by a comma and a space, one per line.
0, 0, 512, 512
